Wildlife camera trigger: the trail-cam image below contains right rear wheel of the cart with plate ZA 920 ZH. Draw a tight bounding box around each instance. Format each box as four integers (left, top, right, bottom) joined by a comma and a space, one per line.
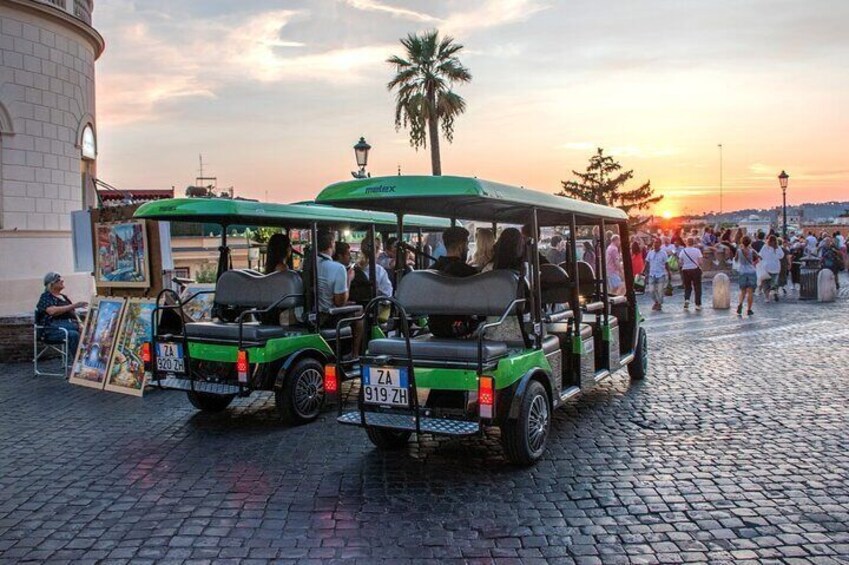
274, 357, 325, 425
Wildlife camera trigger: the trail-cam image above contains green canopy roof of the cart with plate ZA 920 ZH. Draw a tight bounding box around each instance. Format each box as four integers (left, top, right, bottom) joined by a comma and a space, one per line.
133, 198, 451, 231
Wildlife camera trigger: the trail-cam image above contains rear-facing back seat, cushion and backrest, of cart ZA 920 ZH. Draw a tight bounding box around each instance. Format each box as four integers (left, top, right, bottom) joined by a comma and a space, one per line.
185, 270, 304, 343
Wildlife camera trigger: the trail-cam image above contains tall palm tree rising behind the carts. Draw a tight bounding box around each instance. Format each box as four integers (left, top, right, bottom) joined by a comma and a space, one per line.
386, 30, 472, 175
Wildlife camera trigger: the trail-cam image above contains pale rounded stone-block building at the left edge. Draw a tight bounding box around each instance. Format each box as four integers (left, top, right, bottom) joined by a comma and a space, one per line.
0, 0, 104, 316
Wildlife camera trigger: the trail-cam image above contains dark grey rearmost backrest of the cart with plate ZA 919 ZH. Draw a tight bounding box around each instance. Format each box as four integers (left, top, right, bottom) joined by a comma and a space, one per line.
395, 269, 520, 316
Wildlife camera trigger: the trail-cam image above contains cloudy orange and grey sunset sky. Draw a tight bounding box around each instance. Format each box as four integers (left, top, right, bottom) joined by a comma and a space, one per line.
94, 0, 849, 214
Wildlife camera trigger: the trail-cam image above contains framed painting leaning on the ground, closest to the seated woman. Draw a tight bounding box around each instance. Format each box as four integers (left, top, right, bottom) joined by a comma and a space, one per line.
68, 297, 126, 389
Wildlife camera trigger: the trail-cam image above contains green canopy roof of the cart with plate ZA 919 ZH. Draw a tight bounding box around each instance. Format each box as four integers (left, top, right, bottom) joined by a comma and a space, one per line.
316, 176, 628, 226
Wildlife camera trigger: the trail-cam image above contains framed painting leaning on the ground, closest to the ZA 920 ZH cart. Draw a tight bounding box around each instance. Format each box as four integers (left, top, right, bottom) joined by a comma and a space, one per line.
103, 298, 156, 396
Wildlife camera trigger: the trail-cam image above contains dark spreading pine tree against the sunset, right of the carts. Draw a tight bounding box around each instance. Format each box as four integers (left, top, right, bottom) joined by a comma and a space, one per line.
557, 147, 663, 226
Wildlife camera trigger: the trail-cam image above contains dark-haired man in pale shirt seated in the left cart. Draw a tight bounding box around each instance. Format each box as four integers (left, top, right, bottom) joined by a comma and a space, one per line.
316, 230, 363, 352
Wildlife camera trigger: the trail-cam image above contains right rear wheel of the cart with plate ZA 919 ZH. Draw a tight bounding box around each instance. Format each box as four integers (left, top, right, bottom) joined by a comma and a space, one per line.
501, 381, 551, 467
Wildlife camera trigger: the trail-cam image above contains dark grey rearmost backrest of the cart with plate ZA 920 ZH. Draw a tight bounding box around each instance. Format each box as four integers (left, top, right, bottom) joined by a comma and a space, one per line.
215, 270, 304, 310
